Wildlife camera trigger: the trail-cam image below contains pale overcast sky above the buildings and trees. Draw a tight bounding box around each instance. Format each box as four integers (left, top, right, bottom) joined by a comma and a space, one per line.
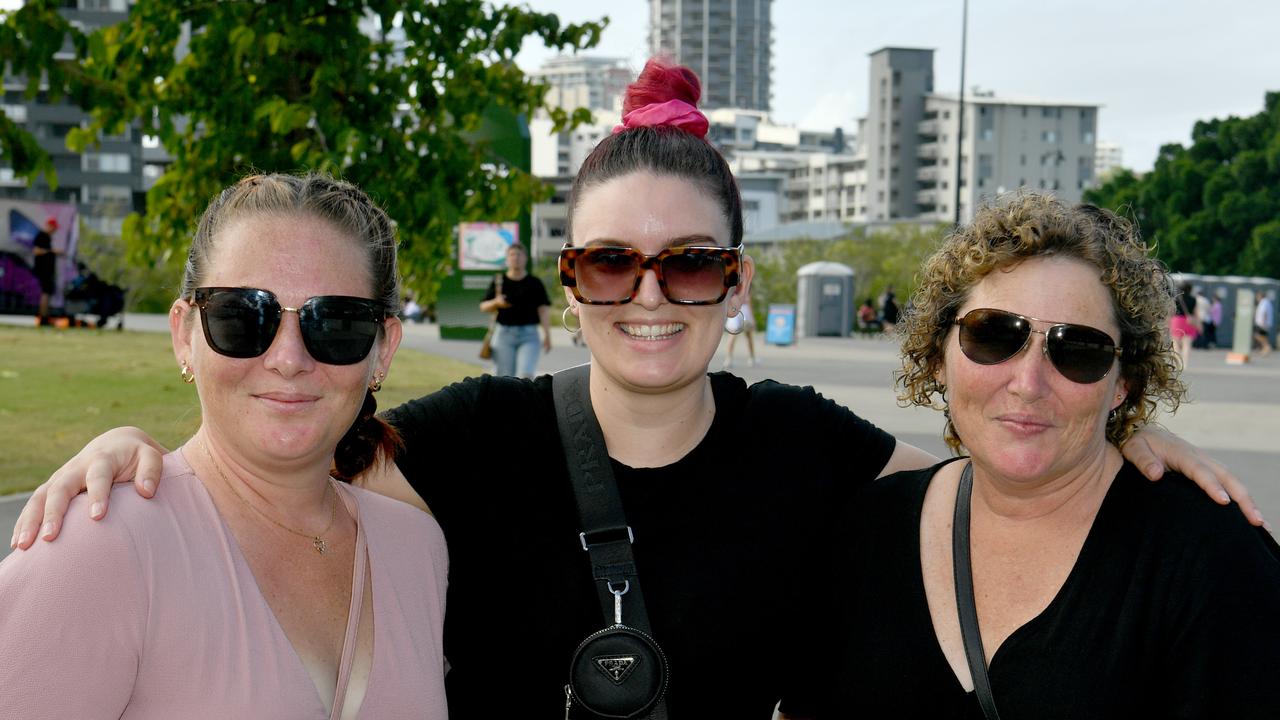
520, 0, 1280, 170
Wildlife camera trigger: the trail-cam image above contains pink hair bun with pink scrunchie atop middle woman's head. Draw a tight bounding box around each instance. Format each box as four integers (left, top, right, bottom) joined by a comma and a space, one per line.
613, 58, 709, 137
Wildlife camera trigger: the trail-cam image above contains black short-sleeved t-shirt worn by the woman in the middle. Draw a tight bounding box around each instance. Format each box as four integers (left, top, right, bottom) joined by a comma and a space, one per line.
388, 373, 893, 720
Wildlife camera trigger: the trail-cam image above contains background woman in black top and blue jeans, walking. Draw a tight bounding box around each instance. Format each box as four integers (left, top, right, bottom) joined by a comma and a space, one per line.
480, 242, 552, 378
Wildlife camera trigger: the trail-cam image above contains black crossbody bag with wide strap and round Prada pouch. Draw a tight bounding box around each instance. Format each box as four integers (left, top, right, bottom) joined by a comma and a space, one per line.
552, 364, 668, 720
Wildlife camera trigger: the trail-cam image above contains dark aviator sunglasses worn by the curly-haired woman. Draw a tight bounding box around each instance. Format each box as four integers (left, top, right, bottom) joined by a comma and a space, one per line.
955, 307, 1121, 384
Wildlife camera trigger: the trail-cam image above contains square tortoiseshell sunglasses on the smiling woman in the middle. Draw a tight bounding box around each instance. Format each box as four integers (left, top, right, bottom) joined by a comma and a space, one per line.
559, 245, 742, 305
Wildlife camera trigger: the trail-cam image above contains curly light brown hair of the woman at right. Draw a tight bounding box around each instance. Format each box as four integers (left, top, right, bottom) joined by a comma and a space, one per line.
896, 192, 1187, 452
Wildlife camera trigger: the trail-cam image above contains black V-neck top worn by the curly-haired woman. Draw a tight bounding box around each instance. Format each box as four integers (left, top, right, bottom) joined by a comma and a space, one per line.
808, 462, 1280, 720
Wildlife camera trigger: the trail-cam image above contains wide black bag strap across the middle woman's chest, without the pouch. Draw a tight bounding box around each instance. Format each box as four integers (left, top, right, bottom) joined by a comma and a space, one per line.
552, 363, 667, 720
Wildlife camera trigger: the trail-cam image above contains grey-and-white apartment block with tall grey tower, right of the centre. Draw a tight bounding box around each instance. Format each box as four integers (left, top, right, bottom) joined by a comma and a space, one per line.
855, 47, 1098, 222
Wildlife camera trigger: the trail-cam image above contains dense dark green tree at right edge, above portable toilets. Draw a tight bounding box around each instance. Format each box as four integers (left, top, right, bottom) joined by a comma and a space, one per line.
1084, 92, 1280, 278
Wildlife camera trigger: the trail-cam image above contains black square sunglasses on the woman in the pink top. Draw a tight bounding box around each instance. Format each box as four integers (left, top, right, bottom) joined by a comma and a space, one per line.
192, 287, 387, 365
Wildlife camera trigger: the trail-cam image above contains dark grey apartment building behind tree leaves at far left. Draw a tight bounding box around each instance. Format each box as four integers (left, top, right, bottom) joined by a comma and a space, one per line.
0, 0, 152, 234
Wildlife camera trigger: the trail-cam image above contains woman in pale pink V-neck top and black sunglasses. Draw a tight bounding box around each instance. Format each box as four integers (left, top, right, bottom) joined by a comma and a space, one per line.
0, 174, 448, 719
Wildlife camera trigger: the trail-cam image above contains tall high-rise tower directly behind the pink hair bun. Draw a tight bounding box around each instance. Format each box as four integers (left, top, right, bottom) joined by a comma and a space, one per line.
649, 0, 773, 110
